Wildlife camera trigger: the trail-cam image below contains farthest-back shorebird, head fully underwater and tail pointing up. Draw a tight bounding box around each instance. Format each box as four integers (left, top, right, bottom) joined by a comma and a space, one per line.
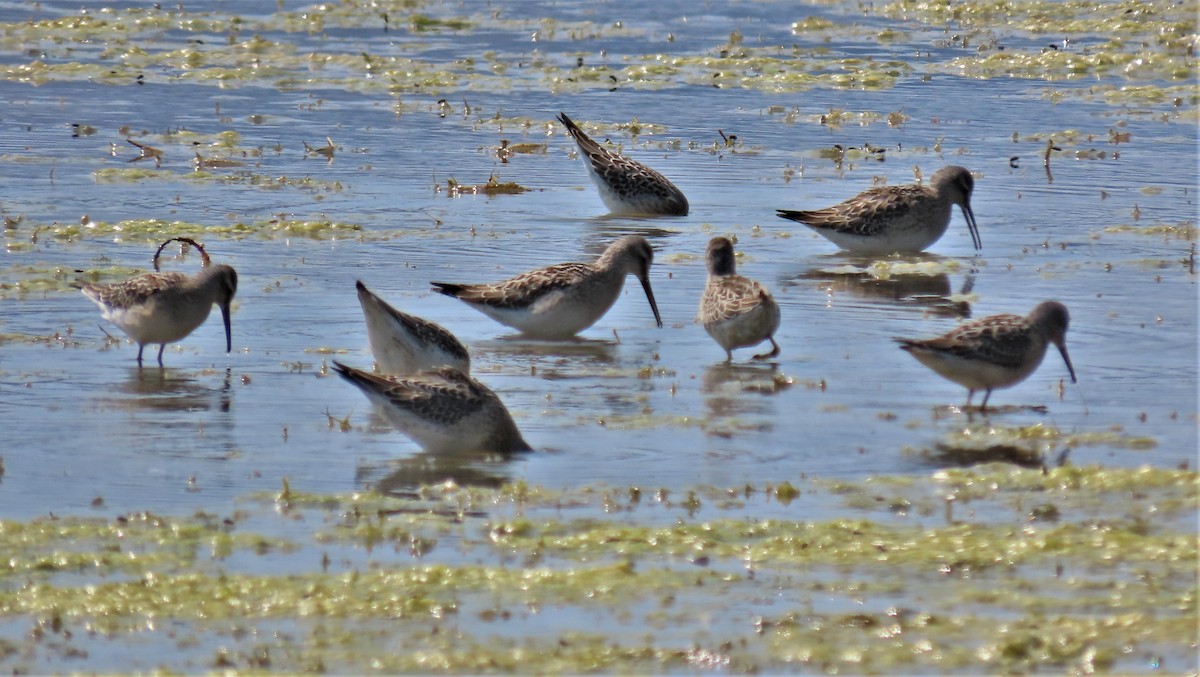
558, 113, 688, 216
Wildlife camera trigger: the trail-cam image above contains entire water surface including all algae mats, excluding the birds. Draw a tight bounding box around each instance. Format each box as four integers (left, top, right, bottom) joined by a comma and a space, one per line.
0, 2, 1198, 673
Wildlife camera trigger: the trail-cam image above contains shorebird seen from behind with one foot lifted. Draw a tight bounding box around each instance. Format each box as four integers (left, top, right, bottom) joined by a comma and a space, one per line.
700, 238, 779, 363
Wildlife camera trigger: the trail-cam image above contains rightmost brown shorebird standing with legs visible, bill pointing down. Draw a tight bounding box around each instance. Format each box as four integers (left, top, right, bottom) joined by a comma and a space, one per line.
896, 301, 1075, 411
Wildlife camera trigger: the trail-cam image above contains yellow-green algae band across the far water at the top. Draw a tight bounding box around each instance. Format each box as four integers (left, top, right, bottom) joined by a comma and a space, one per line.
0, 0, 1196, 94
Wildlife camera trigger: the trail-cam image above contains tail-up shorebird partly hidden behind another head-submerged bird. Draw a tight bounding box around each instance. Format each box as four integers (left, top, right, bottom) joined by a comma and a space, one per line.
355, 281, 470, 373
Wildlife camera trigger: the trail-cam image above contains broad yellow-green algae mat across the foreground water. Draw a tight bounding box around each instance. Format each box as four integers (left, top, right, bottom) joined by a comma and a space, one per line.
0, 465, 1200, 672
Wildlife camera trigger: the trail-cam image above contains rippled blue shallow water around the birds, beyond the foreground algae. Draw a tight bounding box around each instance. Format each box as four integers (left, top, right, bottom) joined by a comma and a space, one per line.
0, 2, 1198, 665
